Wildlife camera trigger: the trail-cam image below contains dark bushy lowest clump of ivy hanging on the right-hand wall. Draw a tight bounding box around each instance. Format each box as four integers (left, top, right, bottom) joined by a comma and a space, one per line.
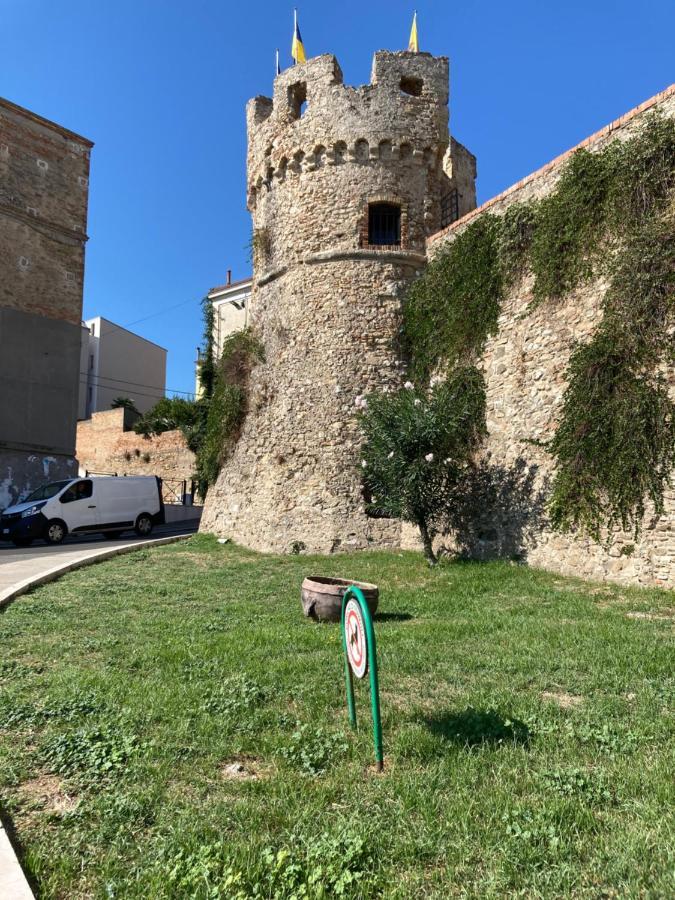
549, 327, 675, 541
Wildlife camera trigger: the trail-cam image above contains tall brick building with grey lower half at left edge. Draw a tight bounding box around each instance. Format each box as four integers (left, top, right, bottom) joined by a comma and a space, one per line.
0, 98, 93, 509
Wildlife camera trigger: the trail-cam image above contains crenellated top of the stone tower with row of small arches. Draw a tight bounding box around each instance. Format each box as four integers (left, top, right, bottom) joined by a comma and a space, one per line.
247, 51, 448, 202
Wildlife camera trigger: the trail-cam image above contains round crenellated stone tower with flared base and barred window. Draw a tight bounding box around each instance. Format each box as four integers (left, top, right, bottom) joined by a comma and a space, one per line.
202, 51, 475, 553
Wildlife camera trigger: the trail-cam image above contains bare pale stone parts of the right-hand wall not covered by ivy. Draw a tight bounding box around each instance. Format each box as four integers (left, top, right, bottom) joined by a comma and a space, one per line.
404, 86, 675, 587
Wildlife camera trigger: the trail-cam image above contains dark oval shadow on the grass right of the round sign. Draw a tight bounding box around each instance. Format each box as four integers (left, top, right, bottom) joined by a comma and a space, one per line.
425, 706, 530, 747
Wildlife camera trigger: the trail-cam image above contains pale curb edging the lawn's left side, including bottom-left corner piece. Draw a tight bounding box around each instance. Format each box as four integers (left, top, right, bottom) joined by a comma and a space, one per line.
0, 534, 192, 900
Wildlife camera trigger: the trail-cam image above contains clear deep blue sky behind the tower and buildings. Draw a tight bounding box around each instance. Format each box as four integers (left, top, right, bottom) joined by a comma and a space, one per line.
0, 0, 675, 391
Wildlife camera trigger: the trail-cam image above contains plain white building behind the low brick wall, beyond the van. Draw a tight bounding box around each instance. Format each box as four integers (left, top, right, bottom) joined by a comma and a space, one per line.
78, 316, 166, 419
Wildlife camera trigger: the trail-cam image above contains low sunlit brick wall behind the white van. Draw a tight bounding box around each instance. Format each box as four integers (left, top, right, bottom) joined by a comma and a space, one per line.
77, 409, 195, 490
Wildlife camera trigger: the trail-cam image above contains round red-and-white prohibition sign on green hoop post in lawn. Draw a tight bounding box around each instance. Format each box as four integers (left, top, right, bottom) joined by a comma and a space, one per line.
342, 585, 384, 772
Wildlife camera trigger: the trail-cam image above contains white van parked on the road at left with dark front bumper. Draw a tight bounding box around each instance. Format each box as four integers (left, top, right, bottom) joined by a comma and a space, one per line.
0, 475, 164, 546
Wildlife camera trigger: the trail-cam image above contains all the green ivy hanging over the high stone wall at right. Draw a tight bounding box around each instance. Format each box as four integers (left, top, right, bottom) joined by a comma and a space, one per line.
403, 114, 675, 539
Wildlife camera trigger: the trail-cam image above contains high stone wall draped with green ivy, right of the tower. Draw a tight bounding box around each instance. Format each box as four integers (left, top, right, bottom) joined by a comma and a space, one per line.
404, 88, 675, 587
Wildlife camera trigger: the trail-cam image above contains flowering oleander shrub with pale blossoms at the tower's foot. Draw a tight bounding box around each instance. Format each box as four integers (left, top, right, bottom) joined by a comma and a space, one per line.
357, 366, 487, 565
